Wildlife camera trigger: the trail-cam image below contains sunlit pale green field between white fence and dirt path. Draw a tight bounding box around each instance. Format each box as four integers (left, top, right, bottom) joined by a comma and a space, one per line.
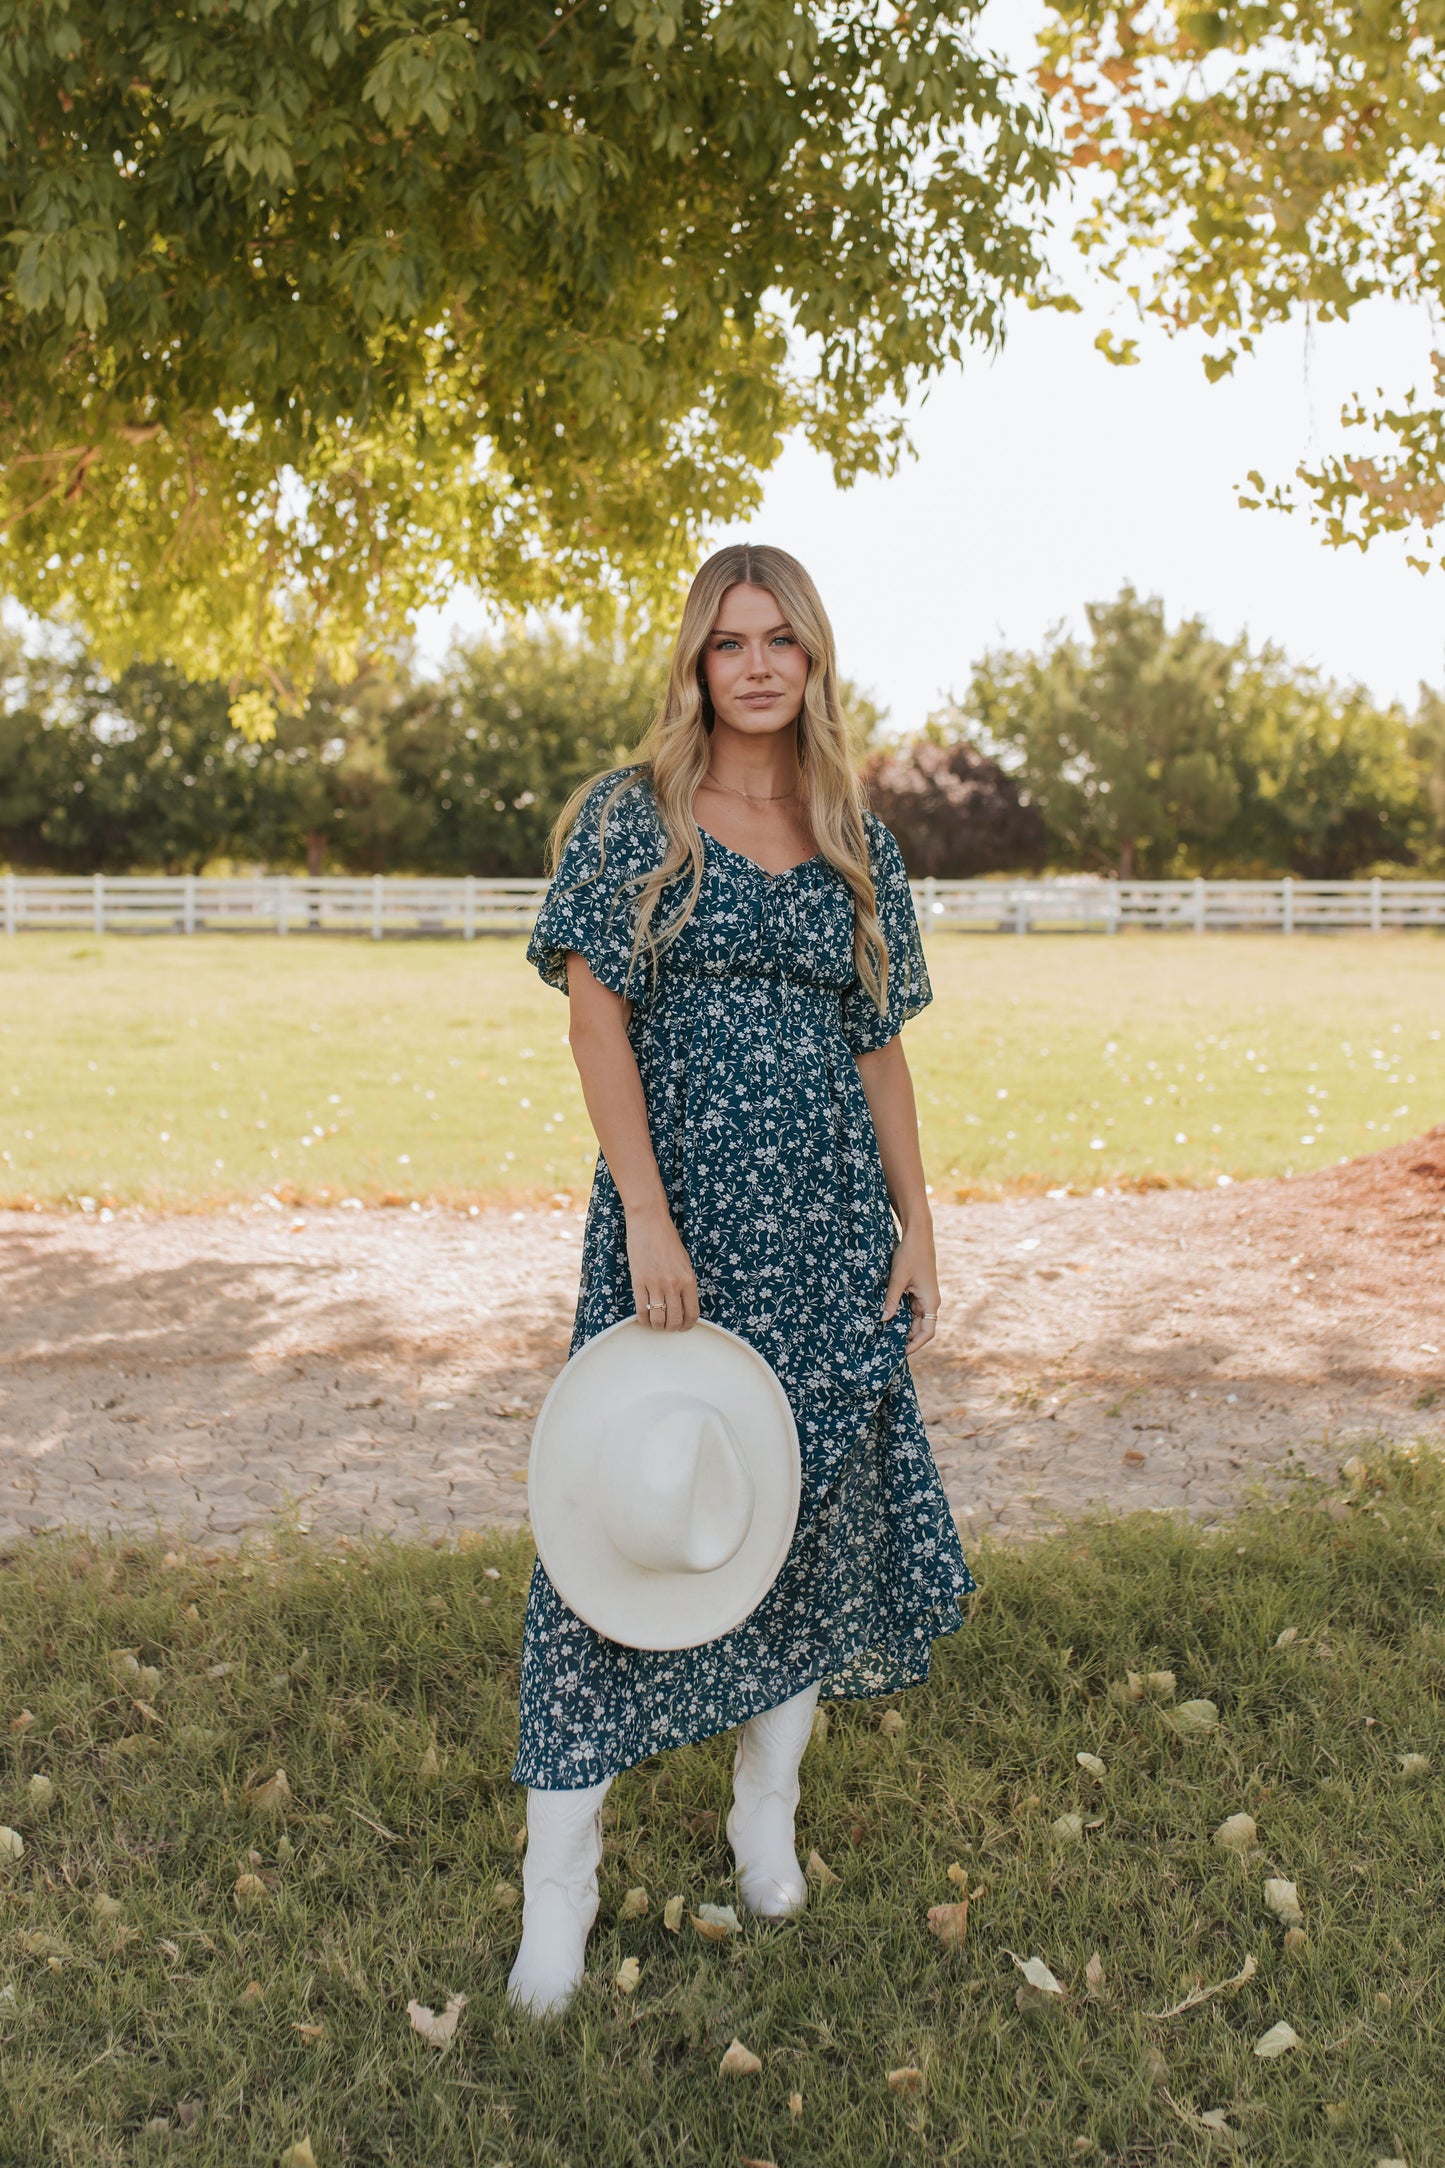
0, 934, 1445, 1210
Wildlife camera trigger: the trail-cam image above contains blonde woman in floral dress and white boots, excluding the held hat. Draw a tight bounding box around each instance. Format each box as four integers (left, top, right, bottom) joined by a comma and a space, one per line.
509, 546, 973, 2014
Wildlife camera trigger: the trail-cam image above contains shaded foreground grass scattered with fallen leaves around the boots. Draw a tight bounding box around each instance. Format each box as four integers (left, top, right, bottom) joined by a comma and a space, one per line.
0, 1453, 1445, 2168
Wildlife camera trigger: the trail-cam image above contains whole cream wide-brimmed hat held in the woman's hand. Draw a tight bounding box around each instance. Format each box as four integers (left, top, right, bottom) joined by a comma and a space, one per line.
526, 1318, 802, 1648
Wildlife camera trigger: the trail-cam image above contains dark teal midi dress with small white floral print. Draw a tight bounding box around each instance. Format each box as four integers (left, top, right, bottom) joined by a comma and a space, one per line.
511, 767, 975, 1791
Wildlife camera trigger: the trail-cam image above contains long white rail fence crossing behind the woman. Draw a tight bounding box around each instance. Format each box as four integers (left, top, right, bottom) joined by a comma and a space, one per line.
0, 874, 1445, 941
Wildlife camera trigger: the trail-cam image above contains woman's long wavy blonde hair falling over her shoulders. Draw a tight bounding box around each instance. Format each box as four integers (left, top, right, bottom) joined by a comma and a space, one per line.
548, 542, 888, 1012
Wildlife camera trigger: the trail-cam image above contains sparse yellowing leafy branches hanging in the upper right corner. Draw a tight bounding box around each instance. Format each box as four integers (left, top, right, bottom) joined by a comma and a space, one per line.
1040, 0, 1445, 570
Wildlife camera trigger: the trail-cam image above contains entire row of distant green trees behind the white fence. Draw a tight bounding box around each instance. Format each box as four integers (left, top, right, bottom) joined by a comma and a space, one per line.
0, 590, 1445, 878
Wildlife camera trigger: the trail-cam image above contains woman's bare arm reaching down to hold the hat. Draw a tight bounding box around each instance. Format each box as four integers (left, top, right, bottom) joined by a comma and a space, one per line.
568, 950, 698, 1333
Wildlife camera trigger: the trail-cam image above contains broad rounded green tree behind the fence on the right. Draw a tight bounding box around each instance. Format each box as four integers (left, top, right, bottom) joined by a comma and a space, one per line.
960, 588, 1423, 880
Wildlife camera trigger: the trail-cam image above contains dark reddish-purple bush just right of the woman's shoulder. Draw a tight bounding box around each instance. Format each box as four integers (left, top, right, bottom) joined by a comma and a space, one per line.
862, 737, 1049, 880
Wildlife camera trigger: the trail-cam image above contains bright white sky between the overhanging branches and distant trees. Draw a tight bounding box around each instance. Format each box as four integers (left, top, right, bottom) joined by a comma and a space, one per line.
418, 0, 1445, 735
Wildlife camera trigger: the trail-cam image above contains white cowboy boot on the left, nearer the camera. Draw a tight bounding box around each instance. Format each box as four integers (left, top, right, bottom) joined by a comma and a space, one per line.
507, 1778, 611, 2018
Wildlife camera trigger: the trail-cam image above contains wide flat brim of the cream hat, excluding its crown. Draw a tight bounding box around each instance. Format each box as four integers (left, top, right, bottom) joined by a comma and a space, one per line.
526, 1318, 802, 1648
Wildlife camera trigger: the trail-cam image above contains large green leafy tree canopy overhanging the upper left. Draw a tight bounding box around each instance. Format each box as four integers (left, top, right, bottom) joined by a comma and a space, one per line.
0, 0, 1055, 733
